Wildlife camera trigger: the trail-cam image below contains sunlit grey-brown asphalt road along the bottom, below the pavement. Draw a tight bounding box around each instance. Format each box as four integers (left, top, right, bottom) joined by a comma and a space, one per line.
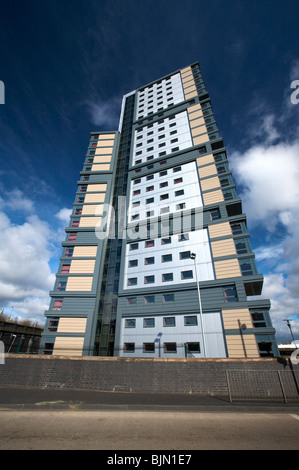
0, 408, 299, 455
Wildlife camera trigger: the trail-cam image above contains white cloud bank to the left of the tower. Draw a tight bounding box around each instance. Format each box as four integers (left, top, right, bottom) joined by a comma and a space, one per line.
0, 190, 70, 323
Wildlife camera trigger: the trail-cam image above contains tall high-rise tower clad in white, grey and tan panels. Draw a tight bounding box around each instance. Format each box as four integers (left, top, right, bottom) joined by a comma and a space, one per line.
41, 63, 279, 358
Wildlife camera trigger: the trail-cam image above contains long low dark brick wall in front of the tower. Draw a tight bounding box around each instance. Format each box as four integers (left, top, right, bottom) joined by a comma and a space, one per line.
0, 355, 299, 396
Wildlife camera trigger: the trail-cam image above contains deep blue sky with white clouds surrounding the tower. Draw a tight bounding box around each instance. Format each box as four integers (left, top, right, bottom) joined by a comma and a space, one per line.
0, 0, 299, 340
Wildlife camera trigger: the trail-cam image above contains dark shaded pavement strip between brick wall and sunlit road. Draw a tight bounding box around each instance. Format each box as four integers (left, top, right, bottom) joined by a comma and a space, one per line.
0, 386, 299, 414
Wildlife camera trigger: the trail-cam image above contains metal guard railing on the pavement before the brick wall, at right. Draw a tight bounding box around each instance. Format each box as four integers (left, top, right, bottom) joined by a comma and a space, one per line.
226, 369, 299, 403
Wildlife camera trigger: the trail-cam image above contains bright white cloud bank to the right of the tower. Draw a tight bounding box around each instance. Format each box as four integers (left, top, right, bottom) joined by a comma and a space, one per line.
230, 78, 299, 339
